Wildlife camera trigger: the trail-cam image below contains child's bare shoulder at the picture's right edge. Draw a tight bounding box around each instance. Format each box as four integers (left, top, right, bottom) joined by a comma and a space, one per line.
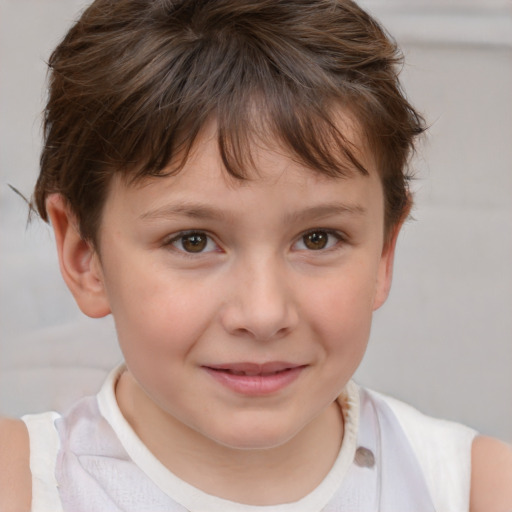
470, 436, 512, 512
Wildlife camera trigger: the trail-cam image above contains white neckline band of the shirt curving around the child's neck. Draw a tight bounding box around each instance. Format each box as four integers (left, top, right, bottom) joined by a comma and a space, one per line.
97, 364, 359, 512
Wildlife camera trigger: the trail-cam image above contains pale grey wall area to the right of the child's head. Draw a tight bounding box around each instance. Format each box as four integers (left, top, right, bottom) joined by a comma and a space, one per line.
358, 0, 512, 440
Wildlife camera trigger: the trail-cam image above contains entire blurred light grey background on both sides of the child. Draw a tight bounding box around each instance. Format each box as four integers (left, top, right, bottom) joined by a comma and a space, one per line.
0, 0, 512, 441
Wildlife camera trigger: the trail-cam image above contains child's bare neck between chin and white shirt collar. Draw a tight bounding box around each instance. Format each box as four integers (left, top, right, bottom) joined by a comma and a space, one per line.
116, 373, 343, 506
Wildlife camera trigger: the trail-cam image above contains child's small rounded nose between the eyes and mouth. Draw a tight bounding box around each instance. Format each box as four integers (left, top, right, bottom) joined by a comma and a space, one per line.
221, 258, 299, 341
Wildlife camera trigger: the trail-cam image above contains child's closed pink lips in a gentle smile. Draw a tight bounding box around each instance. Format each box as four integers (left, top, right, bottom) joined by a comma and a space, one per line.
203, 362, 306, 396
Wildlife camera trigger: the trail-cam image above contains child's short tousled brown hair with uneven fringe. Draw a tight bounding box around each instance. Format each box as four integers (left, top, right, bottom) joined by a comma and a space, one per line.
34, 0, 424, 242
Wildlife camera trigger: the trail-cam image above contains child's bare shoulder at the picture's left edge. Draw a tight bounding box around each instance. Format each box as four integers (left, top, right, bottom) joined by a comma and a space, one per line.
0, 418, 32, 512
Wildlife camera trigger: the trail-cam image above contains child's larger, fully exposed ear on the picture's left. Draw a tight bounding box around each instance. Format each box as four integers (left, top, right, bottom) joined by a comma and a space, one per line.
46, 194, 110, 318
